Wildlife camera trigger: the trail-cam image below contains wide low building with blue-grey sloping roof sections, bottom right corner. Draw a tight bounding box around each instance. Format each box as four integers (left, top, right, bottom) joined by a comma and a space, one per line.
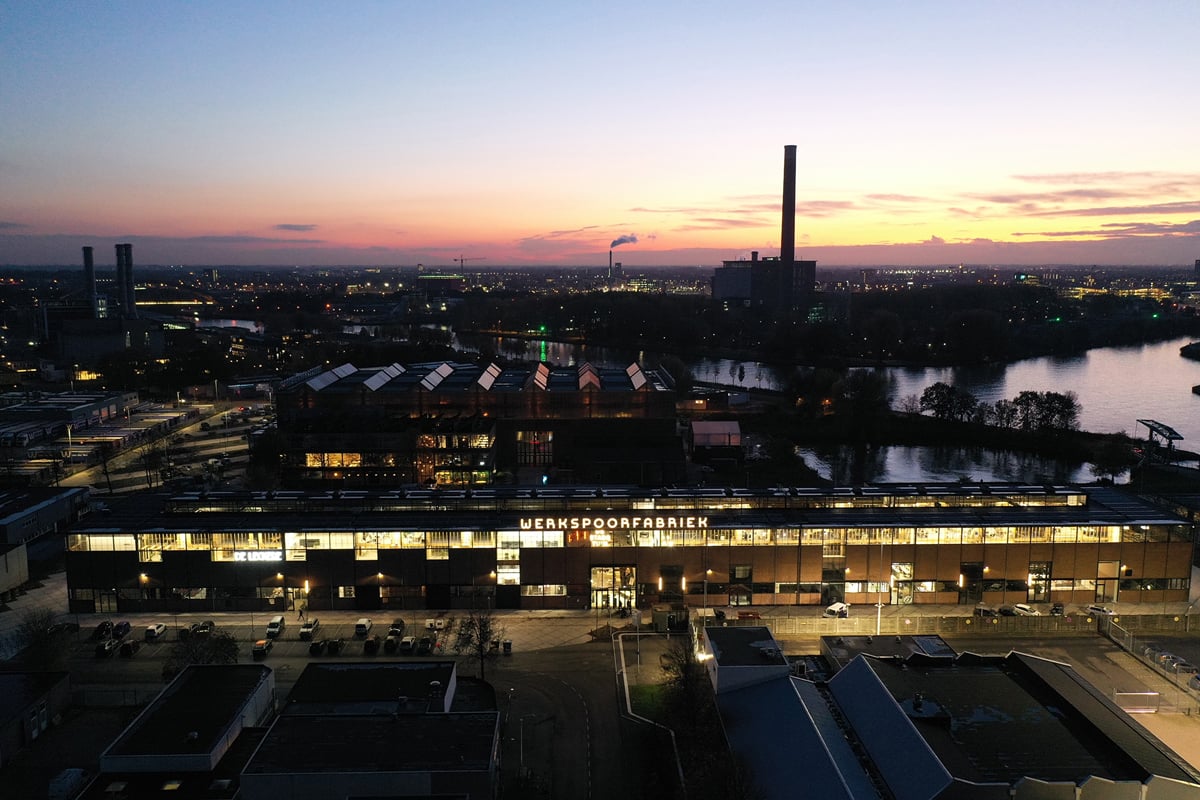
716, 637, 1200, 800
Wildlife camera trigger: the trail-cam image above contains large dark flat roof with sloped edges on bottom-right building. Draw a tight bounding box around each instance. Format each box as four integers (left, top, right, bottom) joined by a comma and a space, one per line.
829, 652, 1200, 783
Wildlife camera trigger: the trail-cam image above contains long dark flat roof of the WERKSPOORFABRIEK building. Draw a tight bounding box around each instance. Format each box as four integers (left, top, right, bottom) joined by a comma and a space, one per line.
72, 485, 1187, 533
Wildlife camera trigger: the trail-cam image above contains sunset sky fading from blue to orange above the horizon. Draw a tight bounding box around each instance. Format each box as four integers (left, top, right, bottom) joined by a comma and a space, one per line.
0, 0, 1200, 267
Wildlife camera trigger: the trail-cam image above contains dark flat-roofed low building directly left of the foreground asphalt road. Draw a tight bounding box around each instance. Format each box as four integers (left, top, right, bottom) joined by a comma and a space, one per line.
241, 661, 500, 800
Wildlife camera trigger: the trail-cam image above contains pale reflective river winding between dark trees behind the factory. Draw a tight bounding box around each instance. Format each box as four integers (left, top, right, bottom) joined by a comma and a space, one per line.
454, 337, 1200, 482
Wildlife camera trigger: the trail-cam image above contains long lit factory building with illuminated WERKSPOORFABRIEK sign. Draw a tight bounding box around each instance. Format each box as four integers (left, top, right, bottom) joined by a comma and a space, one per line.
67, 483, 1194, 613
